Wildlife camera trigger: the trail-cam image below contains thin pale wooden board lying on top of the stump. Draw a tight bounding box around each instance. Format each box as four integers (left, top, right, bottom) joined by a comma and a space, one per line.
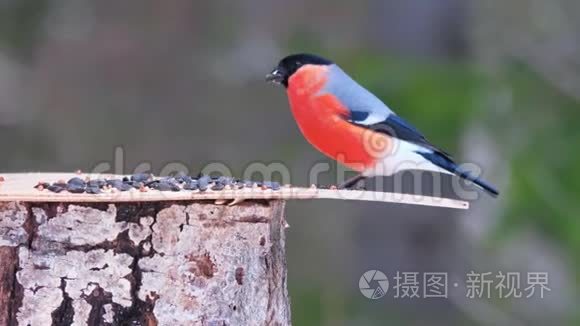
0, 173, 469, 209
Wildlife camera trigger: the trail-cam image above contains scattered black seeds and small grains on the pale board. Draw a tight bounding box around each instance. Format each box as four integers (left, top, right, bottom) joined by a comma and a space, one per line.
34, 173, 280, 194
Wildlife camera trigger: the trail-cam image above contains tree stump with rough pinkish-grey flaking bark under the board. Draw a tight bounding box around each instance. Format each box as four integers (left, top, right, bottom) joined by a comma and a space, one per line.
0, 200, 290, 326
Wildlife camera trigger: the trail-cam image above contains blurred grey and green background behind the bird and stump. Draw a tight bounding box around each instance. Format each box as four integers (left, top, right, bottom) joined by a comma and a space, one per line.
0, 0, 580, 325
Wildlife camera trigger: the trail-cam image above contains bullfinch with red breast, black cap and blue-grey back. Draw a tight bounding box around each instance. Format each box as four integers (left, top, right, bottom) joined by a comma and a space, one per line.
266, 54, 499, 196
